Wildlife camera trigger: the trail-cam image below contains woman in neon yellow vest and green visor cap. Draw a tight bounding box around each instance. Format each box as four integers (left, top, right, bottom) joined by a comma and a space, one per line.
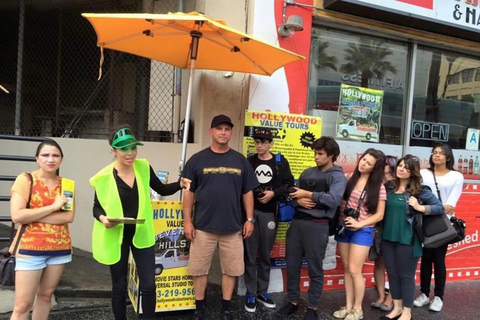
90, 125, 190, 320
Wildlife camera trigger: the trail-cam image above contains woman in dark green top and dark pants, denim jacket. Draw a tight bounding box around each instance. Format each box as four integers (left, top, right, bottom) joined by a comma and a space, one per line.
380, 154, 444, 320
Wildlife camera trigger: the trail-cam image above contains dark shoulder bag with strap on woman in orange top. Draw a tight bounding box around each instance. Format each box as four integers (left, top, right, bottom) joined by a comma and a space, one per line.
0, 172, 33, 286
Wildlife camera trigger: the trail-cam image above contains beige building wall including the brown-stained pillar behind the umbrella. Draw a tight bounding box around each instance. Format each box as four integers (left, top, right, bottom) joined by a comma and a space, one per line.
0, 0, 252, 255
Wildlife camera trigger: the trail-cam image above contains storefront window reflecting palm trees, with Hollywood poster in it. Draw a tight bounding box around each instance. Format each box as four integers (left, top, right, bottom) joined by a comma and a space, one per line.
308, 26, 408, 145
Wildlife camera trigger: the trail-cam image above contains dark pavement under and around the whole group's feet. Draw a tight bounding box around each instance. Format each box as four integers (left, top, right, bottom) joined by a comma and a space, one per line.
0, 244, 480, 320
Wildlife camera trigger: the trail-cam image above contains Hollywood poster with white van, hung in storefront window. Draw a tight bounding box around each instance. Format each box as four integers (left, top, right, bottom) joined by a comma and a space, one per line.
336, 83, 383, 142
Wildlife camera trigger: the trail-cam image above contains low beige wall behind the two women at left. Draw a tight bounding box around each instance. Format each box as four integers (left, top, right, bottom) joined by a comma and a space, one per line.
0, 138, 201, 252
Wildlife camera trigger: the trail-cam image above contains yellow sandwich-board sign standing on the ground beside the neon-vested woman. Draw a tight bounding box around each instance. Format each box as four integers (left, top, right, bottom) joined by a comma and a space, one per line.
128, 201, 195, 312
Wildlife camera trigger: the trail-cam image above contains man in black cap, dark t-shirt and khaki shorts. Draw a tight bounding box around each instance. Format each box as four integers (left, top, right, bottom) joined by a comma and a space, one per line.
182, 115, 258, 320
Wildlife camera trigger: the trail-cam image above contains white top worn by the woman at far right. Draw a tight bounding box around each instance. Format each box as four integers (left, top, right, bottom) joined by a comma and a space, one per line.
420, 169, 463, 218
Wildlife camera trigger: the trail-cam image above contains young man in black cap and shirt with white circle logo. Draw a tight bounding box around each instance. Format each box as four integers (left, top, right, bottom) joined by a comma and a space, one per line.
244, 128, 294, 312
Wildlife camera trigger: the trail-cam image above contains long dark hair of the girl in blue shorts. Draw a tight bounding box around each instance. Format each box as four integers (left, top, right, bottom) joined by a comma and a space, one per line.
343, 148, 385, 214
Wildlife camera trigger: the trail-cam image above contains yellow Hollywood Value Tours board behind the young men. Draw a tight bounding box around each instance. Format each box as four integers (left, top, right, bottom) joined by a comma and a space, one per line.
243, 110, 322, 179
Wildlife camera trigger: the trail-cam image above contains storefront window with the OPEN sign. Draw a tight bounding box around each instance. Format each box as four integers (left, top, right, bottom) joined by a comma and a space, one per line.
410, 46, 480, 149
